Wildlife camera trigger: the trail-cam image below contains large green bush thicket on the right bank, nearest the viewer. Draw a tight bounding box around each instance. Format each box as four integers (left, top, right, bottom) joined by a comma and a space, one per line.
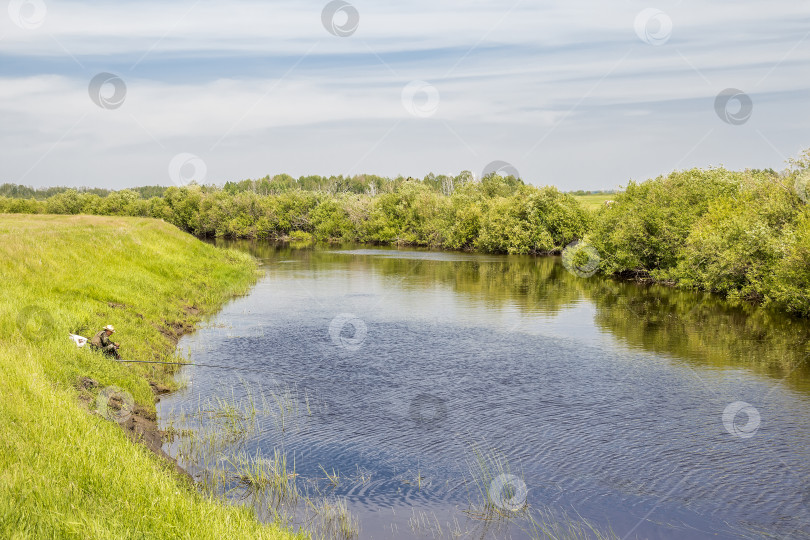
587, 160, 810, 316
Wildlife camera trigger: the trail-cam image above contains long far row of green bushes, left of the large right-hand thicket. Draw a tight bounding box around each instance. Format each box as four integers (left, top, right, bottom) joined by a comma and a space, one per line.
0, 174, 590, 254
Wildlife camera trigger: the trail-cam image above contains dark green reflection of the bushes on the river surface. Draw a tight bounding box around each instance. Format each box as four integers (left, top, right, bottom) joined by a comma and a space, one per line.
217, 240, 810, 392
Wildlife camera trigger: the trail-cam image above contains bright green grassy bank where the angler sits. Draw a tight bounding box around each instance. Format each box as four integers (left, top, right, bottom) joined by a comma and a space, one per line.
0, 215, 302, 538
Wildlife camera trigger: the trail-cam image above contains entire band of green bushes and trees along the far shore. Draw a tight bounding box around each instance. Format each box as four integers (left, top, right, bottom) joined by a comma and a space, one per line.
0, 150, 810, 316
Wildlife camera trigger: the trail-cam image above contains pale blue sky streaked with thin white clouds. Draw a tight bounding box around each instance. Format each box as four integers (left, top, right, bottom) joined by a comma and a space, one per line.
0, 0, 810, 190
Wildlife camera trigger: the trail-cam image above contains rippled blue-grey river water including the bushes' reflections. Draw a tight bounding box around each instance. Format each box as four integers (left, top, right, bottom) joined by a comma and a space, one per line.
158, 242, 810, 539
